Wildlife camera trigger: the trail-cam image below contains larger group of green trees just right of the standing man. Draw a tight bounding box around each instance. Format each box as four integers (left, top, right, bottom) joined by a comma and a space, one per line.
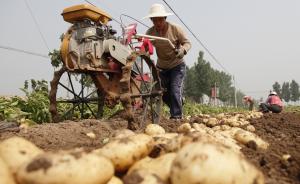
184, 51, 244, 106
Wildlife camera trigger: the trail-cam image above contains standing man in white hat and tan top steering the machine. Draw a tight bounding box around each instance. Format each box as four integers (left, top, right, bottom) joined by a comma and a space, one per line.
144, 4, 191, 119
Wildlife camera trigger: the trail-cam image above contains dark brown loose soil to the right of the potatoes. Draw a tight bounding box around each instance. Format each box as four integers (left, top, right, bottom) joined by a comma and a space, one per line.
242, 113, 300, 184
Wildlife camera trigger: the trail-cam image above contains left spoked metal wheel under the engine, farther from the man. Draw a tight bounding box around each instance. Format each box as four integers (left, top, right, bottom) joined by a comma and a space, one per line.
49, 67, 104, 122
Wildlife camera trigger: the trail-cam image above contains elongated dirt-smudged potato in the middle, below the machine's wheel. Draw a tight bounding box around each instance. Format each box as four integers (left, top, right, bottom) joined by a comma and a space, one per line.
94, 134, 153, 172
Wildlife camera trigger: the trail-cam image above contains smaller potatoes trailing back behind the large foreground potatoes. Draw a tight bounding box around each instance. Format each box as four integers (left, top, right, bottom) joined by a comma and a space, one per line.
184, 111, 269, 151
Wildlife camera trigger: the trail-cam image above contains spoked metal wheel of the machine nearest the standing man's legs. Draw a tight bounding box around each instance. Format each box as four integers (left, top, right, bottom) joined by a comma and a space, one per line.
131, 54, 162, 128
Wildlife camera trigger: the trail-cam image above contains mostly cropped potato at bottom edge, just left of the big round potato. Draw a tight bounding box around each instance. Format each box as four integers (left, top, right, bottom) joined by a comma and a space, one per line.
123, 169, 166, 184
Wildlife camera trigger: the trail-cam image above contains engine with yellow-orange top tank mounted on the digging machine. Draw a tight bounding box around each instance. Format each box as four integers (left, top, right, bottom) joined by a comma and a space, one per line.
61, 4, 131, 71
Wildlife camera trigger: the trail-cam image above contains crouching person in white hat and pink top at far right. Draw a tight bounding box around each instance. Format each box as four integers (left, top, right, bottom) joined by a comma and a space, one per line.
259, 91, 283, 113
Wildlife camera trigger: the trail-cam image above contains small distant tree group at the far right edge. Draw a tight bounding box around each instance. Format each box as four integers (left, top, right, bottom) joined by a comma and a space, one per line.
272, 80, 300, 102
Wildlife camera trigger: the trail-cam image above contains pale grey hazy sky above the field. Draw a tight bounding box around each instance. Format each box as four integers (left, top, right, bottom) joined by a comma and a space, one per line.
0, 0, 300, 98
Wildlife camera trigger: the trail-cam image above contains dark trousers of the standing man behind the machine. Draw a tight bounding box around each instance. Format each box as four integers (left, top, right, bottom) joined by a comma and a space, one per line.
159, 63, 186, 118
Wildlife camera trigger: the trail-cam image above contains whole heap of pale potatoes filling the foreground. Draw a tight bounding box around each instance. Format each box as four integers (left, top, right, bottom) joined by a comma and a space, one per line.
0, 111, 267, 184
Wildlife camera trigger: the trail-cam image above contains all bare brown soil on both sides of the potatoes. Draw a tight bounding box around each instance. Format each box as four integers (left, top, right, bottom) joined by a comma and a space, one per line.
0, 112, 300, 184
